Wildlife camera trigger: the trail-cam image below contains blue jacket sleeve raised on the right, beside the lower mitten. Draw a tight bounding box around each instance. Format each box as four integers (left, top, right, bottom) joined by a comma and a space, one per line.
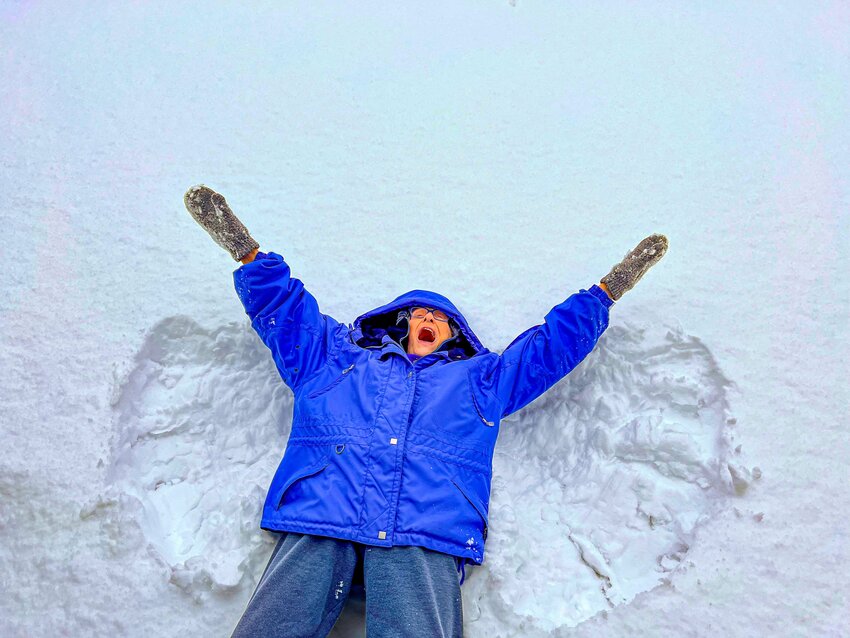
495, 284, 614, 418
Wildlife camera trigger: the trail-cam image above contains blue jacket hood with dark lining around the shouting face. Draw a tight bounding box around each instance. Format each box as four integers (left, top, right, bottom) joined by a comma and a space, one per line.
351, 289, 487, 359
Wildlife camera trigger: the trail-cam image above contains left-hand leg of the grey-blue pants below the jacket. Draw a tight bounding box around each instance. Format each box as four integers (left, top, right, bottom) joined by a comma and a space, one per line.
232, 532, 357, 638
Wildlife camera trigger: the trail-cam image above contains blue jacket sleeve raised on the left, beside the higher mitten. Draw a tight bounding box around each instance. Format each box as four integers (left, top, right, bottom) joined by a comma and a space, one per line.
233, 252, 345, 391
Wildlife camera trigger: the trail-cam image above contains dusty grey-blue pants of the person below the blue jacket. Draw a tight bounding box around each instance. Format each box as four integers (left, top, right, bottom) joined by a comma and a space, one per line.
231, 532, 463, 638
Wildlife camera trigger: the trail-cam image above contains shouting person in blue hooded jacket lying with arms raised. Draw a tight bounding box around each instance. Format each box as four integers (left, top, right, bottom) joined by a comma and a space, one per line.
184, 186, 667, 638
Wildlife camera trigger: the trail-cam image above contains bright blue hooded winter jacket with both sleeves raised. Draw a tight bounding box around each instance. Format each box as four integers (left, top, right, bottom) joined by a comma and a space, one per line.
233, 252, 614, 580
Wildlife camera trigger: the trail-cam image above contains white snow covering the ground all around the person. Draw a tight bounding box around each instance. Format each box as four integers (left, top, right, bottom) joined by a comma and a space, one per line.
0, 0, 850, 638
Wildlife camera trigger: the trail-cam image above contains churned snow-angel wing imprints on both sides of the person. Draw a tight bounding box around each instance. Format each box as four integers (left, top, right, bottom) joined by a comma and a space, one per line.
97, 316, 751, 635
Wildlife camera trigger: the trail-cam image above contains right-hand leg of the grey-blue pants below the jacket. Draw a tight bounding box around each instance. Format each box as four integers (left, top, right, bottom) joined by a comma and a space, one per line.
363, 546, 463, 638
